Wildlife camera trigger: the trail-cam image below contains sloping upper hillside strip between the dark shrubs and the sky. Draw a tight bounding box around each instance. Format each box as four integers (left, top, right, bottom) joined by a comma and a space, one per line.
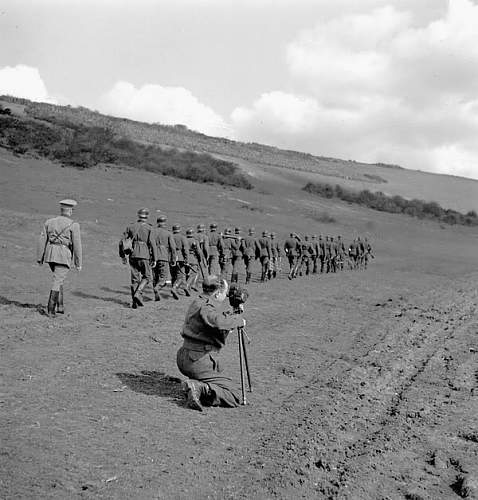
0, 97, 478, 212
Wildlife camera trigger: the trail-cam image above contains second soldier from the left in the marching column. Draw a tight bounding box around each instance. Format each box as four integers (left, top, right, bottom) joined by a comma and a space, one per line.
151, 215, 176, 301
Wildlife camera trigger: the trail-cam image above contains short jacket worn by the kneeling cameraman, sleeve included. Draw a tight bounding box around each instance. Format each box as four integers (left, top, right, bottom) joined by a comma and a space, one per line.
181, 295, 243, 351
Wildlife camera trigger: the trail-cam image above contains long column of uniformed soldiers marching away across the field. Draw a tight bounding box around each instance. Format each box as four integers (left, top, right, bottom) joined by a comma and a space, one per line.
119, 208, 373, 309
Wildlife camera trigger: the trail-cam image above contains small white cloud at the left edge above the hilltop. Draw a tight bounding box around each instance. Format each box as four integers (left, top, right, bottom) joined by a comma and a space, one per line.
0, 64, 56, 103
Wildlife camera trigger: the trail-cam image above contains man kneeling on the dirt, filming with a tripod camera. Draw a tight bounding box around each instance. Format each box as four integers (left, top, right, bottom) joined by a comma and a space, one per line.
177, 275, 246, 411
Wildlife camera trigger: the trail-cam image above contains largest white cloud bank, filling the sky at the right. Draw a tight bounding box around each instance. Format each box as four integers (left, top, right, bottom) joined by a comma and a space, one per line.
231, 0, 478, 178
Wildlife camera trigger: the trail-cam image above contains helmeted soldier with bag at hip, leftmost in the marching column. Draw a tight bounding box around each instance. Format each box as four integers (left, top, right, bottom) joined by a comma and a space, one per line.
119, 208, 158, 309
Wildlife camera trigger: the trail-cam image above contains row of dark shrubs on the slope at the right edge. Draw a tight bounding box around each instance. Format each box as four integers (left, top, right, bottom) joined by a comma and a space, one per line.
303, 182, 478, 226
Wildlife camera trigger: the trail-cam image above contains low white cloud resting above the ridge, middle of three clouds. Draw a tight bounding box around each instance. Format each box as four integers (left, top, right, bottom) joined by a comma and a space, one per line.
99, 82, 232, 137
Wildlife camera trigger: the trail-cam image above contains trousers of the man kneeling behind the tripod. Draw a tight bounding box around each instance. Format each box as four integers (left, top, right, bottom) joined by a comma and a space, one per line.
176, 341, 240, 408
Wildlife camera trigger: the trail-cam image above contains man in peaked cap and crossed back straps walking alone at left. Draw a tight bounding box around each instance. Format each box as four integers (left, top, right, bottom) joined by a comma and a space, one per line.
37, 200, 82, 318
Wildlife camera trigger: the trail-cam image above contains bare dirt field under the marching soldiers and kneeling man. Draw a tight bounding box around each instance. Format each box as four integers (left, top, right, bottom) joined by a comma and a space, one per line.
0, 150, 478, 500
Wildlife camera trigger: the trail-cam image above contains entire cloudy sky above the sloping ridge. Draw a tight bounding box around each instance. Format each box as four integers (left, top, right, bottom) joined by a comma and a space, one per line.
0, 0, 478, 179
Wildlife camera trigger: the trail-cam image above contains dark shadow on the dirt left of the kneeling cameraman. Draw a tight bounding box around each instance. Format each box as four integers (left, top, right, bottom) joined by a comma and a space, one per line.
116, 370, 185, 406
